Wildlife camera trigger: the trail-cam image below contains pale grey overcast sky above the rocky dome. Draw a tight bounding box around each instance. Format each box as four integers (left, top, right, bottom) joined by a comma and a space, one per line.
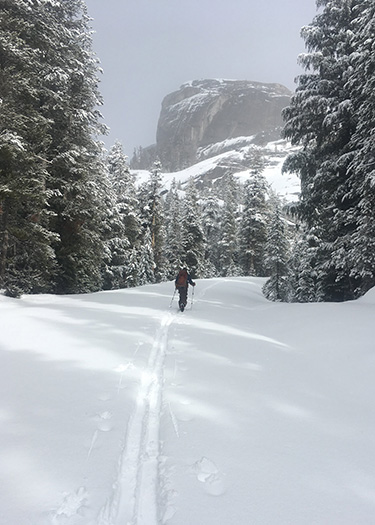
86, 0, 316, 156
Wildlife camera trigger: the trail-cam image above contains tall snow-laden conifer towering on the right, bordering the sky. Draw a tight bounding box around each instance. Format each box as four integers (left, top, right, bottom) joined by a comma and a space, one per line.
284, 0, 362, 300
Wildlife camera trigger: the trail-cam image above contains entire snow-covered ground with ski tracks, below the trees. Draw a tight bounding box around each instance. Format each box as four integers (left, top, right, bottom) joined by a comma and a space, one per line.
0, 278, 375, 525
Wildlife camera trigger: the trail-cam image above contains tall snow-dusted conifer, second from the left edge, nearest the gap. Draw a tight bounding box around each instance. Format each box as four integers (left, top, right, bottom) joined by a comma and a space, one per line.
40, 0, 105, 293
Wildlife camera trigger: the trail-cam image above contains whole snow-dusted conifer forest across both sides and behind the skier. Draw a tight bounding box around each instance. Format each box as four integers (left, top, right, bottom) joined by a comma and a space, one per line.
0, 0, 375, 302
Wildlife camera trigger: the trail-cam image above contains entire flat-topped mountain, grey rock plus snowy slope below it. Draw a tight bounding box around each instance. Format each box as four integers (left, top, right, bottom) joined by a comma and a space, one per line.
131, 79, 299, 200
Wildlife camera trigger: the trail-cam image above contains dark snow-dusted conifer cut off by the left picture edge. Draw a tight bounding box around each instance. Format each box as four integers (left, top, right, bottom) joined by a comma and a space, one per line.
0, 0, 56, 295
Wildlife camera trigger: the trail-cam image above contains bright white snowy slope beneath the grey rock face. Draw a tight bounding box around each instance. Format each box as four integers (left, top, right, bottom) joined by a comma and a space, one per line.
131, 137, 300, 202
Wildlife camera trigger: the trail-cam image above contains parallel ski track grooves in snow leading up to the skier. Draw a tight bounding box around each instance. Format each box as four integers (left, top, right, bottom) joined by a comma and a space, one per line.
98, 312, 175, 525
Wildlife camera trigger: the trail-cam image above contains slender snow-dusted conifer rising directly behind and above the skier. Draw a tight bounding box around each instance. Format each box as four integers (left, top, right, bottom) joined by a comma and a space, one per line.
182, 179, 206, 279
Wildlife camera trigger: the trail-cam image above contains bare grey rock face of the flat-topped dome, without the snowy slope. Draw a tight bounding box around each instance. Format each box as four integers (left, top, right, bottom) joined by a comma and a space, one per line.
156, 80, 291, 171
